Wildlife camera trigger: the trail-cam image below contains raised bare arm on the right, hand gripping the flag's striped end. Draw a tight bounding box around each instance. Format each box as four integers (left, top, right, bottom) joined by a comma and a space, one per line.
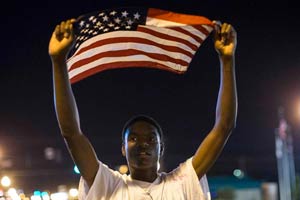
192, 22, 237, 179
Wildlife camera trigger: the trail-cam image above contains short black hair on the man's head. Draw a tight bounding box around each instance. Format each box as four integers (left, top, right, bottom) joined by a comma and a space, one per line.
122, 114, 164, 144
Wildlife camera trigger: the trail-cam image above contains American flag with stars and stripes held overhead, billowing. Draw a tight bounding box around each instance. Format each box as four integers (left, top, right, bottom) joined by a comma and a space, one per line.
67, 7, 213, 83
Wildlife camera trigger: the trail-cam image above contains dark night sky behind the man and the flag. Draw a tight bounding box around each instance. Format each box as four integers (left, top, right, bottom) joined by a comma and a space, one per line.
0, 0, 300, 194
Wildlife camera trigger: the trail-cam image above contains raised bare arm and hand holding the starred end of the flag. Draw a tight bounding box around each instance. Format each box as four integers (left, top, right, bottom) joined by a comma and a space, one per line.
49, 19, 98, 186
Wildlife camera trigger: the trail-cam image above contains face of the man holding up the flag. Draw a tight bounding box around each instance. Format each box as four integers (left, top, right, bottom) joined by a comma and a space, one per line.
122, 121, 161, 169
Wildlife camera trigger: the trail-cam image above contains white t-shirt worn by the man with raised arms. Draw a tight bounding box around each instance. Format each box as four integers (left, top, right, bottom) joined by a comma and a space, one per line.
79, 158, 211, 200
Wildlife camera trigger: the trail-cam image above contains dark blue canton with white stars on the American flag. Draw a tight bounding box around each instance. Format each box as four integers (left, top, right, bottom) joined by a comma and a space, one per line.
69, 7, 148, 56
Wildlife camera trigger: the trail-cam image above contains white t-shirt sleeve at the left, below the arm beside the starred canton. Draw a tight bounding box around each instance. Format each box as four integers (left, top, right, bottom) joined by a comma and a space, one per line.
78, 161, 122, 200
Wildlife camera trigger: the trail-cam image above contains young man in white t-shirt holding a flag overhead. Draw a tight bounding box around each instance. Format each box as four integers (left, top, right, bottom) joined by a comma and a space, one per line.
49, 19, 237, 200
